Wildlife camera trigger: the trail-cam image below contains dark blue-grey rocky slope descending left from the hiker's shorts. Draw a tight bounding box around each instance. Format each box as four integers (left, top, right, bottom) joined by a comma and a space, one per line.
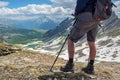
44, 18, 73, 40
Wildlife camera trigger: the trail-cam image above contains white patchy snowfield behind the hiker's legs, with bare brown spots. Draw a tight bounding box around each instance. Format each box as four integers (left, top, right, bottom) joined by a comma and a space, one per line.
21, 35, 120, 62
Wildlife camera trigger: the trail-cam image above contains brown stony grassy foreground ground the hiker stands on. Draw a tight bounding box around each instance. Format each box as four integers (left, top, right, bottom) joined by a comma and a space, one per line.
0, 44, 120, 80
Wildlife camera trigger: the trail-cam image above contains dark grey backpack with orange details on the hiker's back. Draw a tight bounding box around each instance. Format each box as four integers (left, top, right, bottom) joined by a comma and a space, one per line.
93, 0, 116, 21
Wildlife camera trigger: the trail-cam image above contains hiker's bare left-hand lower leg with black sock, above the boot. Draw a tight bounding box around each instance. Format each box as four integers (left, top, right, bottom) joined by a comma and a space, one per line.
68, 39, 74, 63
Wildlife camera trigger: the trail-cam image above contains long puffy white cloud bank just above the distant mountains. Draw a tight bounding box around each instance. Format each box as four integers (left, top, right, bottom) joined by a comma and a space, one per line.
0, 4, 72, 20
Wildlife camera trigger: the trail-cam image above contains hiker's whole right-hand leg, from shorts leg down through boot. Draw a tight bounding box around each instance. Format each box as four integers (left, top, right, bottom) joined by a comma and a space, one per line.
82, 28, 97, 74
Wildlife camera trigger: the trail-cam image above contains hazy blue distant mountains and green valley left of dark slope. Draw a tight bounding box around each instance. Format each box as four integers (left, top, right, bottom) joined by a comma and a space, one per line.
0, 16, 58, 44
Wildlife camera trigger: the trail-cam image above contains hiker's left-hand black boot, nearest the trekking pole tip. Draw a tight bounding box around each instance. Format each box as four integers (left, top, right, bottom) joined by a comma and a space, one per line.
60, 62, 74, 73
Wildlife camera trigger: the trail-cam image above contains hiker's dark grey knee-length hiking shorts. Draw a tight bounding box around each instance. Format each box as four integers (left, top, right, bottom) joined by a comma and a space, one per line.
69, 12, 99, 42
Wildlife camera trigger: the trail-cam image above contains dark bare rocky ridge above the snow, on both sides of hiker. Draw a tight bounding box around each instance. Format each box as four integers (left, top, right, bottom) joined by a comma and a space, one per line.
44, 12, 120, 40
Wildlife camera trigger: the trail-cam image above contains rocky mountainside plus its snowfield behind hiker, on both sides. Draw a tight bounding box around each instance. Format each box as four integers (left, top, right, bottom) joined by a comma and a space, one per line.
28, 14, 120, 62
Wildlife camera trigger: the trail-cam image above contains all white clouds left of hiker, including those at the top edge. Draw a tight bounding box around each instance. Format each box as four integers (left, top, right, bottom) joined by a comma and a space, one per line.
0, 0, 76, 22
